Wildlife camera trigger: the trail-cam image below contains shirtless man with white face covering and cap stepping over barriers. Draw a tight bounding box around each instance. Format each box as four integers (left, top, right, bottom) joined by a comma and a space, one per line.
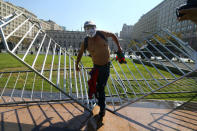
76, 21, 122, 118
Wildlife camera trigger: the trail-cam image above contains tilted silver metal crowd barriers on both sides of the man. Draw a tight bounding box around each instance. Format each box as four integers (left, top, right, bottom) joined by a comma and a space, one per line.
0, 12, 197, 112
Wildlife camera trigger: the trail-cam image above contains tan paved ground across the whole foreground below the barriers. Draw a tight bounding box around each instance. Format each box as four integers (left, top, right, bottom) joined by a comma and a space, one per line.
0, 101, 197, 131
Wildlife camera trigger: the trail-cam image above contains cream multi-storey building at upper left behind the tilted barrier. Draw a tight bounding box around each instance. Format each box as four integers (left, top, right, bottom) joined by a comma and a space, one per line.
0, 0, 63, 38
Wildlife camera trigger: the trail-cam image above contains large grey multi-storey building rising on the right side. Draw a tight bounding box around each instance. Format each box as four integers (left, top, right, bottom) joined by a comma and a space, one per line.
132, 0, 197, 49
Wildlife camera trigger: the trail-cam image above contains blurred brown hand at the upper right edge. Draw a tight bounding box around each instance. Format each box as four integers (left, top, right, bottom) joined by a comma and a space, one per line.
178, 8, 197, 24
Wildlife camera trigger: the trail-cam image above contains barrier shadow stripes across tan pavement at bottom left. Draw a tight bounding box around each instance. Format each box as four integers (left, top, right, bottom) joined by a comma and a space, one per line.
0, 102, 90, 131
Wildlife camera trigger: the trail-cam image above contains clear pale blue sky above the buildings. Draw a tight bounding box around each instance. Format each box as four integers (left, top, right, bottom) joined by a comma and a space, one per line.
5, 0, 163, 33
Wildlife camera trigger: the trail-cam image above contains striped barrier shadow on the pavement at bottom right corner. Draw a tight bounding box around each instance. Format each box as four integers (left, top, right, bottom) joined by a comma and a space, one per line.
148, 96, 197, 131
